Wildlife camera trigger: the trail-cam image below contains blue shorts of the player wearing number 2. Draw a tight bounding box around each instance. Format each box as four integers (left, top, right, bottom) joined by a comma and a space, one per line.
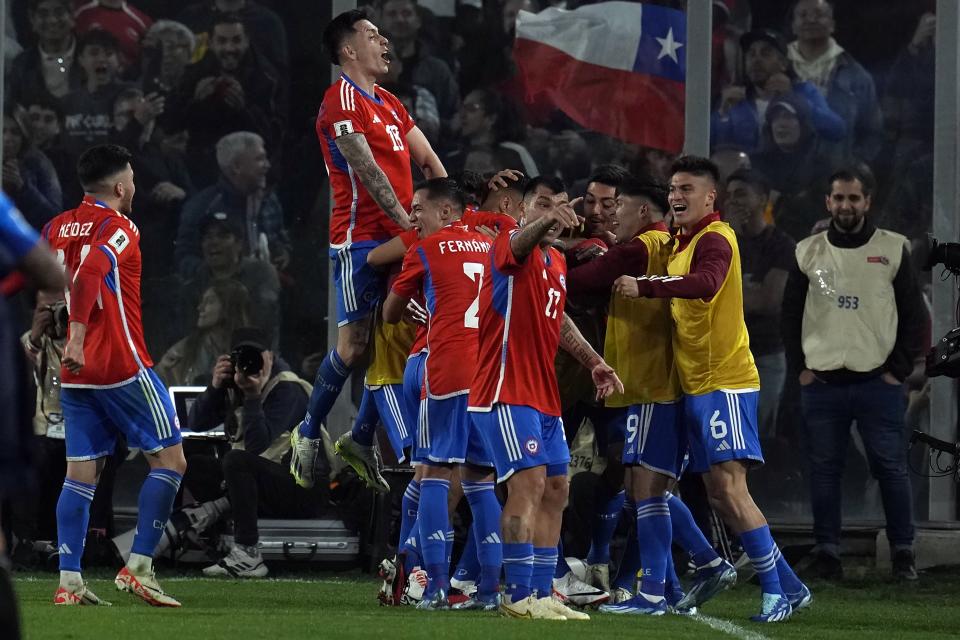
413, 393, 493, 467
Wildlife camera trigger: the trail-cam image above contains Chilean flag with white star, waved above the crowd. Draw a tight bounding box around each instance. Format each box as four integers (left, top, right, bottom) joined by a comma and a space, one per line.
513, 2, 686, 152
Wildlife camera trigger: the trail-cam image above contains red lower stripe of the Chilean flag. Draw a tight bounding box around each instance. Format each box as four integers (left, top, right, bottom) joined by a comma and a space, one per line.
513, 38, 684, 153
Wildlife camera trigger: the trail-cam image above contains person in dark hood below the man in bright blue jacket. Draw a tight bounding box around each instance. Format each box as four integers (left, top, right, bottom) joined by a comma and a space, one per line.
751, 95, 833, 240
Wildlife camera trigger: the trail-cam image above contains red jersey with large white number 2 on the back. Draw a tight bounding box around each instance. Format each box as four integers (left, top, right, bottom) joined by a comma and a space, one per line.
393, 222, 490, 399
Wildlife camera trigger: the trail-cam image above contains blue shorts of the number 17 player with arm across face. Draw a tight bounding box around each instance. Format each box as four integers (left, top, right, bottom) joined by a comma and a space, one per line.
470, 402, 570, 482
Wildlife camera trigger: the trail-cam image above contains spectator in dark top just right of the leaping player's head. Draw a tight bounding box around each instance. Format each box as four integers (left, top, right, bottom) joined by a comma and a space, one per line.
378, 0, 460, 122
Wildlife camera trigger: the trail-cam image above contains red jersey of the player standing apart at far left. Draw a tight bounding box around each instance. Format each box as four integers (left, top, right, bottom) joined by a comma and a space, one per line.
43, 196, 153, 388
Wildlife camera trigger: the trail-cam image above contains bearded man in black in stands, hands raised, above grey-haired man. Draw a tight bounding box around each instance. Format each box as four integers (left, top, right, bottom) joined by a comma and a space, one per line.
185, 14, 286, 184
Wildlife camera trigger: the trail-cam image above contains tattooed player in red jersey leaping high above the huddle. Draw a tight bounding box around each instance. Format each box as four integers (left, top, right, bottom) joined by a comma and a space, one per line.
290, 10, 447, 491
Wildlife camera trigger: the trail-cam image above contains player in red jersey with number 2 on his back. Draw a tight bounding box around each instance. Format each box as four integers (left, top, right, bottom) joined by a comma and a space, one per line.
383, 178, 502, 609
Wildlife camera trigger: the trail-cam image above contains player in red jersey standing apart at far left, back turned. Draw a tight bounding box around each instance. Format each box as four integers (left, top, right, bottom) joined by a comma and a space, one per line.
43, 145, 187, 607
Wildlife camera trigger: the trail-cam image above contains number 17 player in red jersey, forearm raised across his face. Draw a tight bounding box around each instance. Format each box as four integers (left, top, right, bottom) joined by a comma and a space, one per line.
469, 176, 623, 620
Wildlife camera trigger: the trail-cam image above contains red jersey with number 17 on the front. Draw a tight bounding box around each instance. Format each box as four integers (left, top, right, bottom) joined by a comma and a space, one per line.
468, 231, 567, 416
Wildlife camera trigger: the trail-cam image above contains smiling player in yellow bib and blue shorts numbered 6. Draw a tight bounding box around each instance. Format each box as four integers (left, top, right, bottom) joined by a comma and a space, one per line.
614, 156, 811, 622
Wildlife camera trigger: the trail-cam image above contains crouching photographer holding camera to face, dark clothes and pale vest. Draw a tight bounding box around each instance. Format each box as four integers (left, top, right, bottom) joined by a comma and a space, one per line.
185, 327, 326, 578
